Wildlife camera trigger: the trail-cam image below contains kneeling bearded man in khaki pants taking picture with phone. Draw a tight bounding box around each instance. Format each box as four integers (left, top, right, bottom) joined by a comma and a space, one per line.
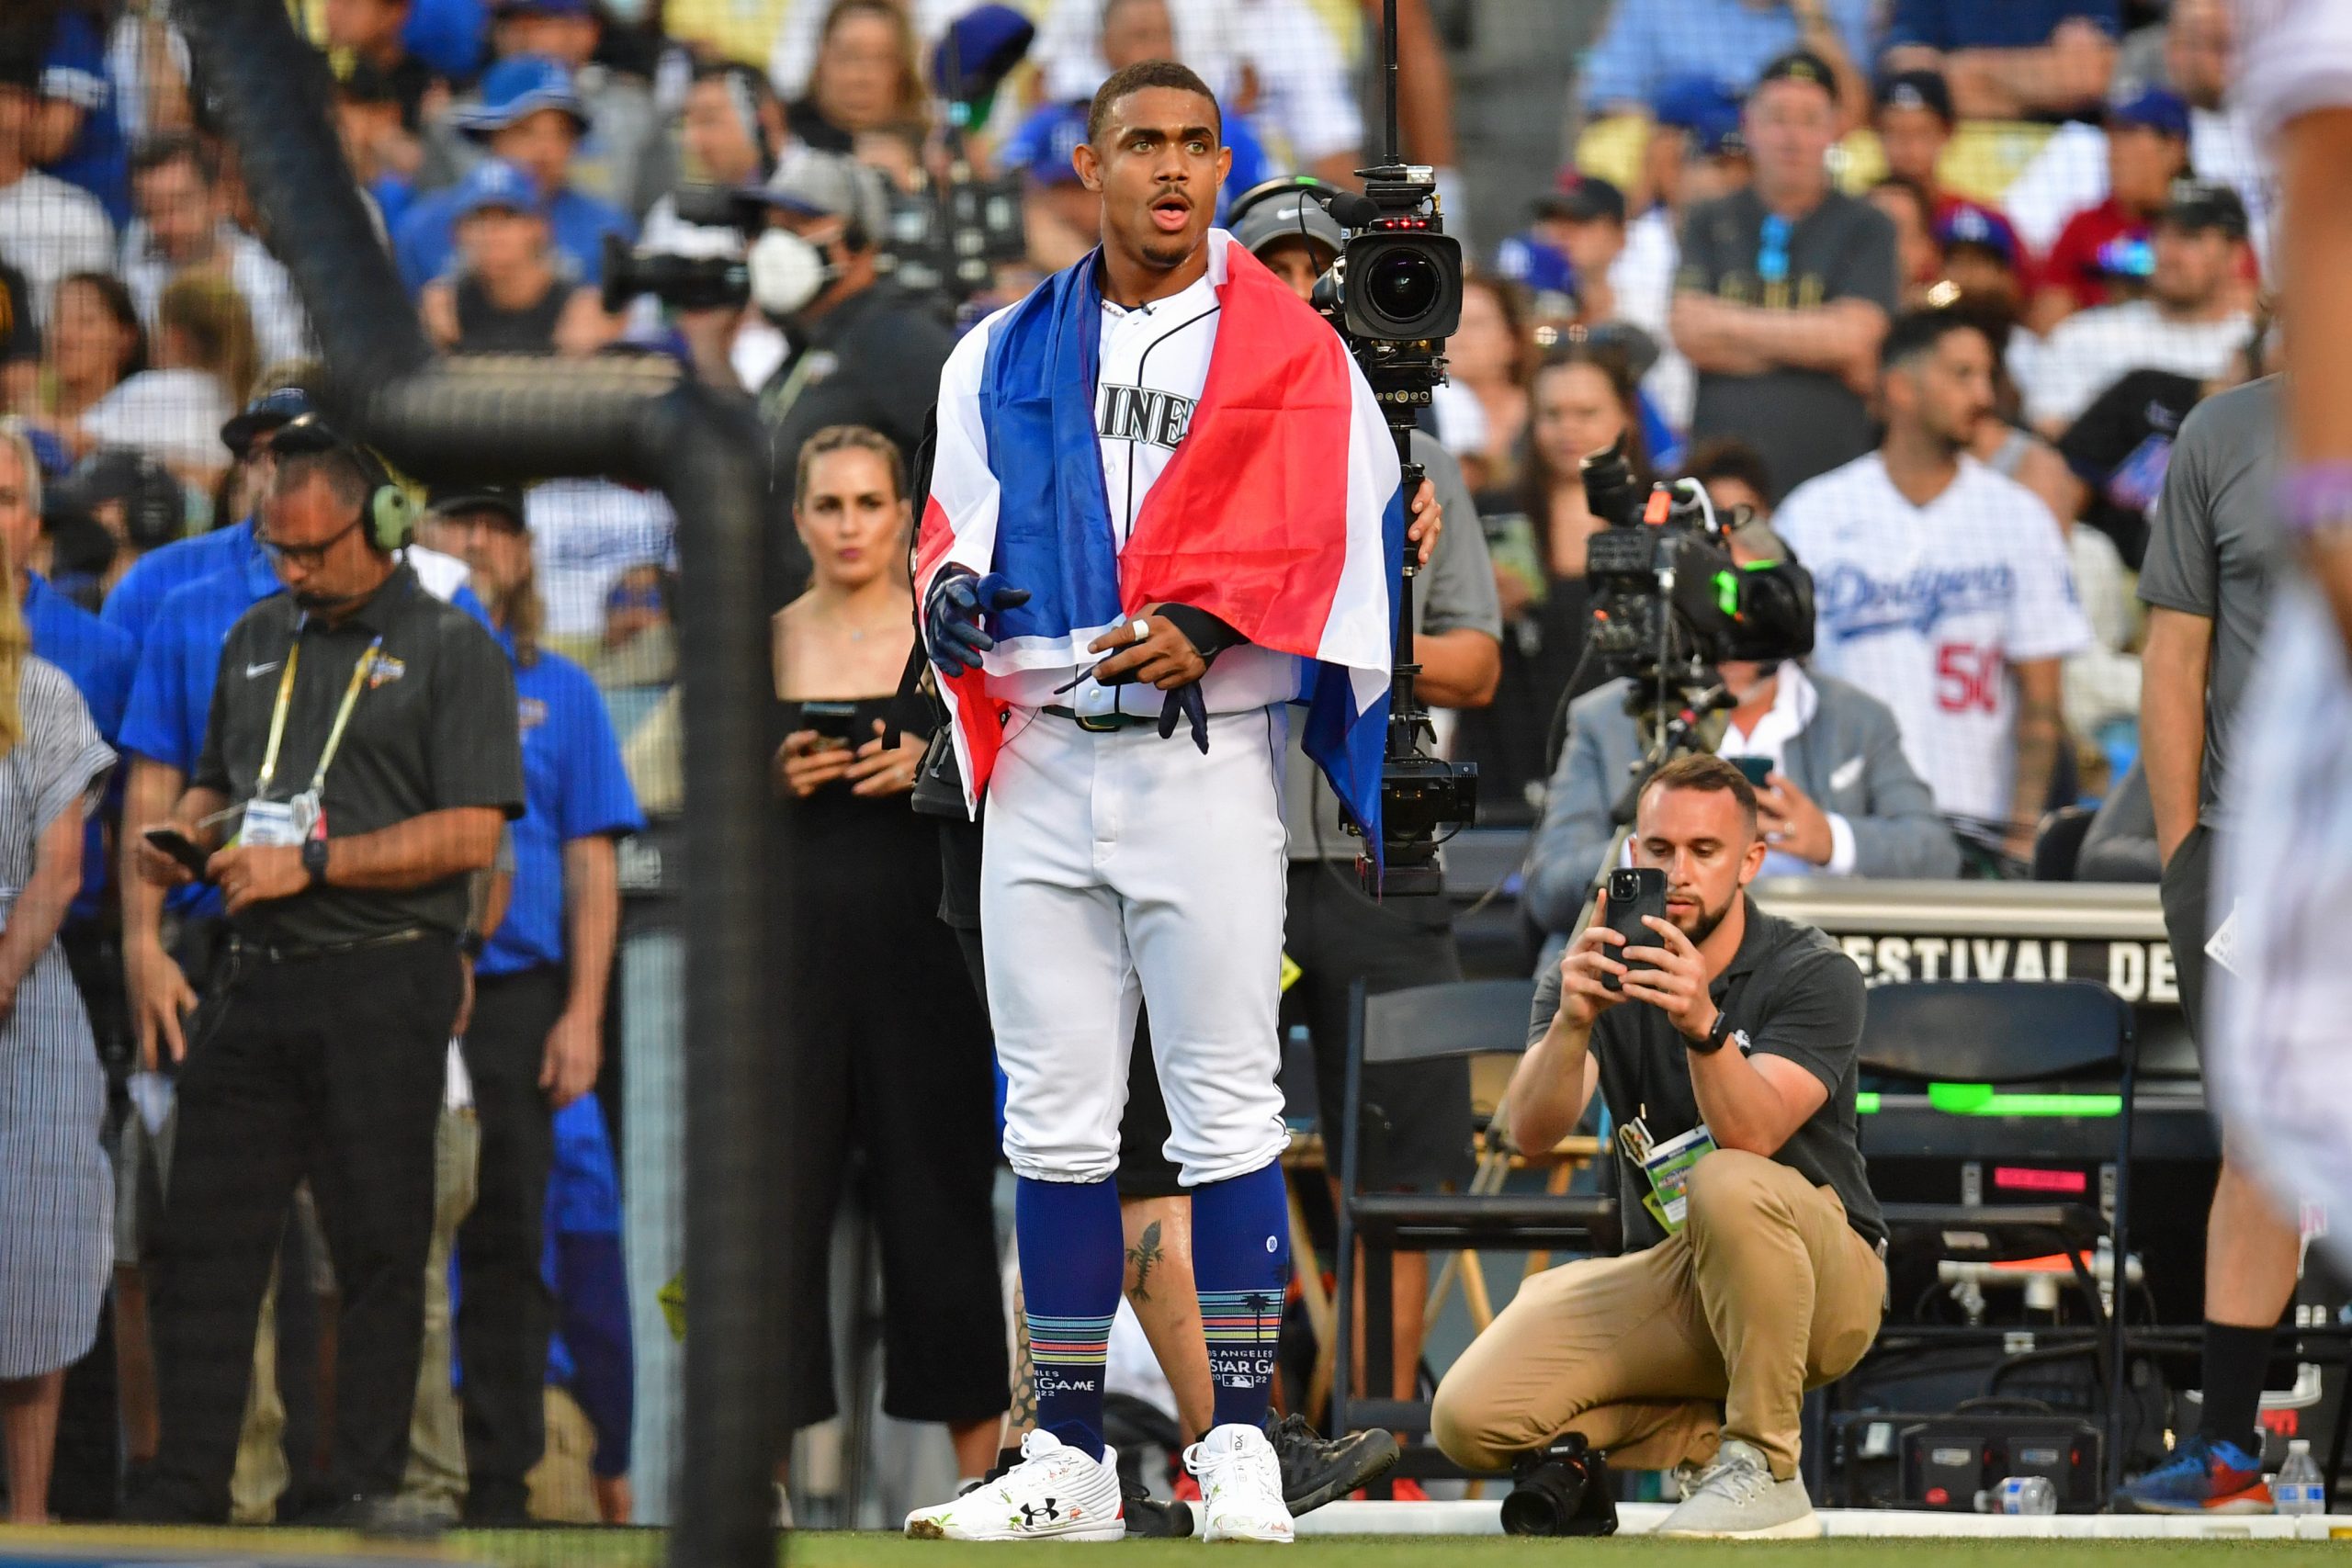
1432, 757, 1886, 1538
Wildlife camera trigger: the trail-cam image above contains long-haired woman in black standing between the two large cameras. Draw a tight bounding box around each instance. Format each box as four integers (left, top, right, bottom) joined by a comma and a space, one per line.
1453, 344, 1649, 823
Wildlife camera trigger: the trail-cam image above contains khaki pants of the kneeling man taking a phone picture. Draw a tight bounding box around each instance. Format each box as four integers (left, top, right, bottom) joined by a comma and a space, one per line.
1430, 1149, 1886, 1481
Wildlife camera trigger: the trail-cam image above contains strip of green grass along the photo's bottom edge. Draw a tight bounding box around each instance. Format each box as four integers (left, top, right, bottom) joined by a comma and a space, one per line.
0, 1528, 2352, 1568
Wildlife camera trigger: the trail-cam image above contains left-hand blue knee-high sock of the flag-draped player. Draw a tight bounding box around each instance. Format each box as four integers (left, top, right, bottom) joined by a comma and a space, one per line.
1013, 1176, 1126, 1460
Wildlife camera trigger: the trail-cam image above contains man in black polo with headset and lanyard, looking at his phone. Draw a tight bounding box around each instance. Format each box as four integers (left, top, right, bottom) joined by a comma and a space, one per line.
134, 416, 522, 1523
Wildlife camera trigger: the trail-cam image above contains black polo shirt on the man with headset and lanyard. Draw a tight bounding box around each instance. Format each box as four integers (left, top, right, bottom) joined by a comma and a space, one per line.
193, 567, 522, 947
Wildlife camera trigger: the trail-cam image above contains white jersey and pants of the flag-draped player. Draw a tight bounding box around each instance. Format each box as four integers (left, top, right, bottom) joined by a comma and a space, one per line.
938, 247, 1301, 1187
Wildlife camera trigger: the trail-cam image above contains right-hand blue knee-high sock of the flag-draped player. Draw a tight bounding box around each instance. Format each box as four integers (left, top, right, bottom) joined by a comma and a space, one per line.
1193, 1164, 1291, 1427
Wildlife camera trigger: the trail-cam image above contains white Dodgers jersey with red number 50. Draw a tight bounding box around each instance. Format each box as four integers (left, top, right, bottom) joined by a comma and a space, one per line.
1773, 451, 2091, 832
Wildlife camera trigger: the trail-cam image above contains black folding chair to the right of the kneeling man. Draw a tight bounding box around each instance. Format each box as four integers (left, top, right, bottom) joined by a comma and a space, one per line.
1860, 980, 2138, 1493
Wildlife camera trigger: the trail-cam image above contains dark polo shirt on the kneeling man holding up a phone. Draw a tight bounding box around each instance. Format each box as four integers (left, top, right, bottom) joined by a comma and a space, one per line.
1529, 894, 1886, 1253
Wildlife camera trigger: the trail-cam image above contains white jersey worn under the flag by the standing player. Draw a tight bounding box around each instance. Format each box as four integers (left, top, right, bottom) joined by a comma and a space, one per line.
941, 257, 1301, 719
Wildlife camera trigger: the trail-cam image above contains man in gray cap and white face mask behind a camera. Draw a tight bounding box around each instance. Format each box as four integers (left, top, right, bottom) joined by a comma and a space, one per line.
738, 152, 955, 590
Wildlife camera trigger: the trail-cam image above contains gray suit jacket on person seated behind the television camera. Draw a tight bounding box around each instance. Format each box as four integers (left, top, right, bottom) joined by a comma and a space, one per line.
1521, 670, 1959, 933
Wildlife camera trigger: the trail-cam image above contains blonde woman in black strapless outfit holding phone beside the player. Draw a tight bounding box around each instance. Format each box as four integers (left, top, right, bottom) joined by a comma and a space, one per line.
776, 425, 1009, 1476
